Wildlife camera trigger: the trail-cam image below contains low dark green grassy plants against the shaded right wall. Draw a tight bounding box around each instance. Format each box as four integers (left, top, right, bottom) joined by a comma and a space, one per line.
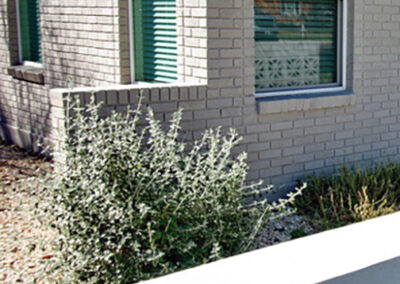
295, 163, 400, 229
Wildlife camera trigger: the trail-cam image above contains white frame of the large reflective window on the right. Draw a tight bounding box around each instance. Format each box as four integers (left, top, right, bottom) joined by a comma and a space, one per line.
255, 0, 348, 98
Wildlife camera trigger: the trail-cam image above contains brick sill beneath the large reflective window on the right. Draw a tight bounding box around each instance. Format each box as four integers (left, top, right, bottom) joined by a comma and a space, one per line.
256, 90, 355, 114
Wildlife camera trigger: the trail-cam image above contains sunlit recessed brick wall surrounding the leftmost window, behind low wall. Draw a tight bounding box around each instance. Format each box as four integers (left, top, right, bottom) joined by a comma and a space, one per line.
0, 0, 125, 150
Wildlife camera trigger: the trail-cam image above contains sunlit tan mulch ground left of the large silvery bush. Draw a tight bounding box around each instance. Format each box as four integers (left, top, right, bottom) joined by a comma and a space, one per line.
0, 140, 57, 283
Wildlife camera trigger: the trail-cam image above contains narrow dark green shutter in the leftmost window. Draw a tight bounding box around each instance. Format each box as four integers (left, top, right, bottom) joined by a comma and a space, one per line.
18, 0, 42, 62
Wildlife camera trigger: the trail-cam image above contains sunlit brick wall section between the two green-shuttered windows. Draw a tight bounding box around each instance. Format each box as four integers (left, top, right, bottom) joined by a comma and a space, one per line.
41, 0, 126, 88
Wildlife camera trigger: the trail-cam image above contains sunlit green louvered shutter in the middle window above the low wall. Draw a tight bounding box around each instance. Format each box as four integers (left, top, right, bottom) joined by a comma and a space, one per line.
133, 0, 177, 83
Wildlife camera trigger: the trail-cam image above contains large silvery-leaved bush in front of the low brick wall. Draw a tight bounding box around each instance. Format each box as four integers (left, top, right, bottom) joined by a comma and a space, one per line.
41, 96, 304, 283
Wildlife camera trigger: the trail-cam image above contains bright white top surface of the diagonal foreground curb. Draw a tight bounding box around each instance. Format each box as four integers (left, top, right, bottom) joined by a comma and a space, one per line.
145, 213, 400, 284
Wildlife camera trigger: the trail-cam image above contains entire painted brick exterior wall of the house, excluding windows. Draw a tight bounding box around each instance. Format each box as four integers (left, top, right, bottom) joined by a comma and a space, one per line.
0, 0, 400, 187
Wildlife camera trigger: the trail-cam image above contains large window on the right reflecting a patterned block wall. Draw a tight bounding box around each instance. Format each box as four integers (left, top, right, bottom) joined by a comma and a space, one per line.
255, 0, 346, 97
